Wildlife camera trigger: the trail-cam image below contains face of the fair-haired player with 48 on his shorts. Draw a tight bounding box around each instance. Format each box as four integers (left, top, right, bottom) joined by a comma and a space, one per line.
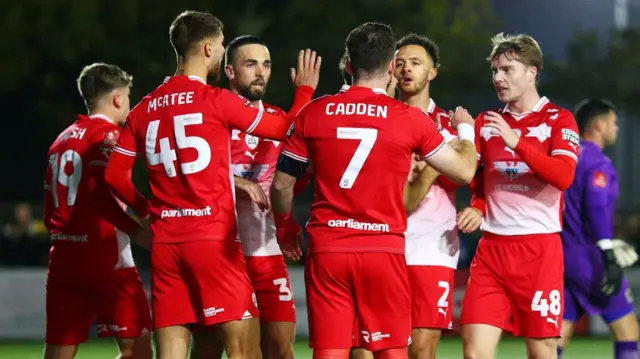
491, 53, 537, 103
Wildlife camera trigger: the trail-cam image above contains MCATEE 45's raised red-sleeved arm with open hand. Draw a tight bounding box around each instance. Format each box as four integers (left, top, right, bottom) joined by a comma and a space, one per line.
217, 49, 322, 141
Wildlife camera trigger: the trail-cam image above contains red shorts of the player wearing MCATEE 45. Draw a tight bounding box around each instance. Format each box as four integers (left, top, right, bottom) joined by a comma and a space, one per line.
151, 240, 258, 329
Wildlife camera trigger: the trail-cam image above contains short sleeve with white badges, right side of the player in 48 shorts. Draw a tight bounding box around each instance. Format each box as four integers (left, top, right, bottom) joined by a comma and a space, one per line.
550, 111, 580, 161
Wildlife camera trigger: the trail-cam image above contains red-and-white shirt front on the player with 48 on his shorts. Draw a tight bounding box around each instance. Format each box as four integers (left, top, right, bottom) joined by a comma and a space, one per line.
475, 97, 579, 236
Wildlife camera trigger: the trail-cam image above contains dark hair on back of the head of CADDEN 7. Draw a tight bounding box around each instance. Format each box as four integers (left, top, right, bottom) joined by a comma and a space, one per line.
345, 22, 396, 78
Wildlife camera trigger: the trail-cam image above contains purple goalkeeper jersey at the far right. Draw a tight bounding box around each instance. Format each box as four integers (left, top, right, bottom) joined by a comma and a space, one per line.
561, 140, 618, 272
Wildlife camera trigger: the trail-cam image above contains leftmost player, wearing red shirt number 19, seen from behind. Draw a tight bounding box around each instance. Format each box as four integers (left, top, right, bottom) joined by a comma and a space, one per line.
44, 63, 152, 359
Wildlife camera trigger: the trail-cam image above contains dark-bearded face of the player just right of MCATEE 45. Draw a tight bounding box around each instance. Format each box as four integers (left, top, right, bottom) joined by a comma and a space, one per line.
225, 44, 271, 101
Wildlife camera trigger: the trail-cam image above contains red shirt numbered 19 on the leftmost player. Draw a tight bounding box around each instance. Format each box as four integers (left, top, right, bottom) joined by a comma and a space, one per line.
44, 115, 138, 270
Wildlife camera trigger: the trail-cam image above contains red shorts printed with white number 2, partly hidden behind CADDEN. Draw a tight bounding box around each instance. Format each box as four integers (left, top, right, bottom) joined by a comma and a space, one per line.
407, 265, 455, 330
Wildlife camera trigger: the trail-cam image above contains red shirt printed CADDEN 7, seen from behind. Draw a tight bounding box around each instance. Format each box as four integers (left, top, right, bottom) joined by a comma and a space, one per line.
282, 87, 445, 254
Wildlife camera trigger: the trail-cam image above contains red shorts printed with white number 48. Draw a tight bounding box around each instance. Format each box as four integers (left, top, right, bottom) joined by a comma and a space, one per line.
460, 233, 564, 338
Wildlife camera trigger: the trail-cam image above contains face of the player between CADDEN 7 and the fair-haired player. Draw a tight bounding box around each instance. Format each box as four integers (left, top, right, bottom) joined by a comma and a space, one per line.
394, 45, 438, 95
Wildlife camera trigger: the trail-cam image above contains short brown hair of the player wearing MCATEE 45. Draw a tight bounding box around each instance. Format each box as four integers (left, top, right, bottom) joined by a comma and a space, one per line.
169, 10, 223, 57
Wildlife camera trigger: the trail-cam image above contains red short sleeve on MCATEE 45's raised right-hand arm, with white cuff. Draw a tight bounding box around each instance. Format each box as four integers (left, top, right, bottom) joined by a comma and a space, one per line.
211, 88, 264, 134
